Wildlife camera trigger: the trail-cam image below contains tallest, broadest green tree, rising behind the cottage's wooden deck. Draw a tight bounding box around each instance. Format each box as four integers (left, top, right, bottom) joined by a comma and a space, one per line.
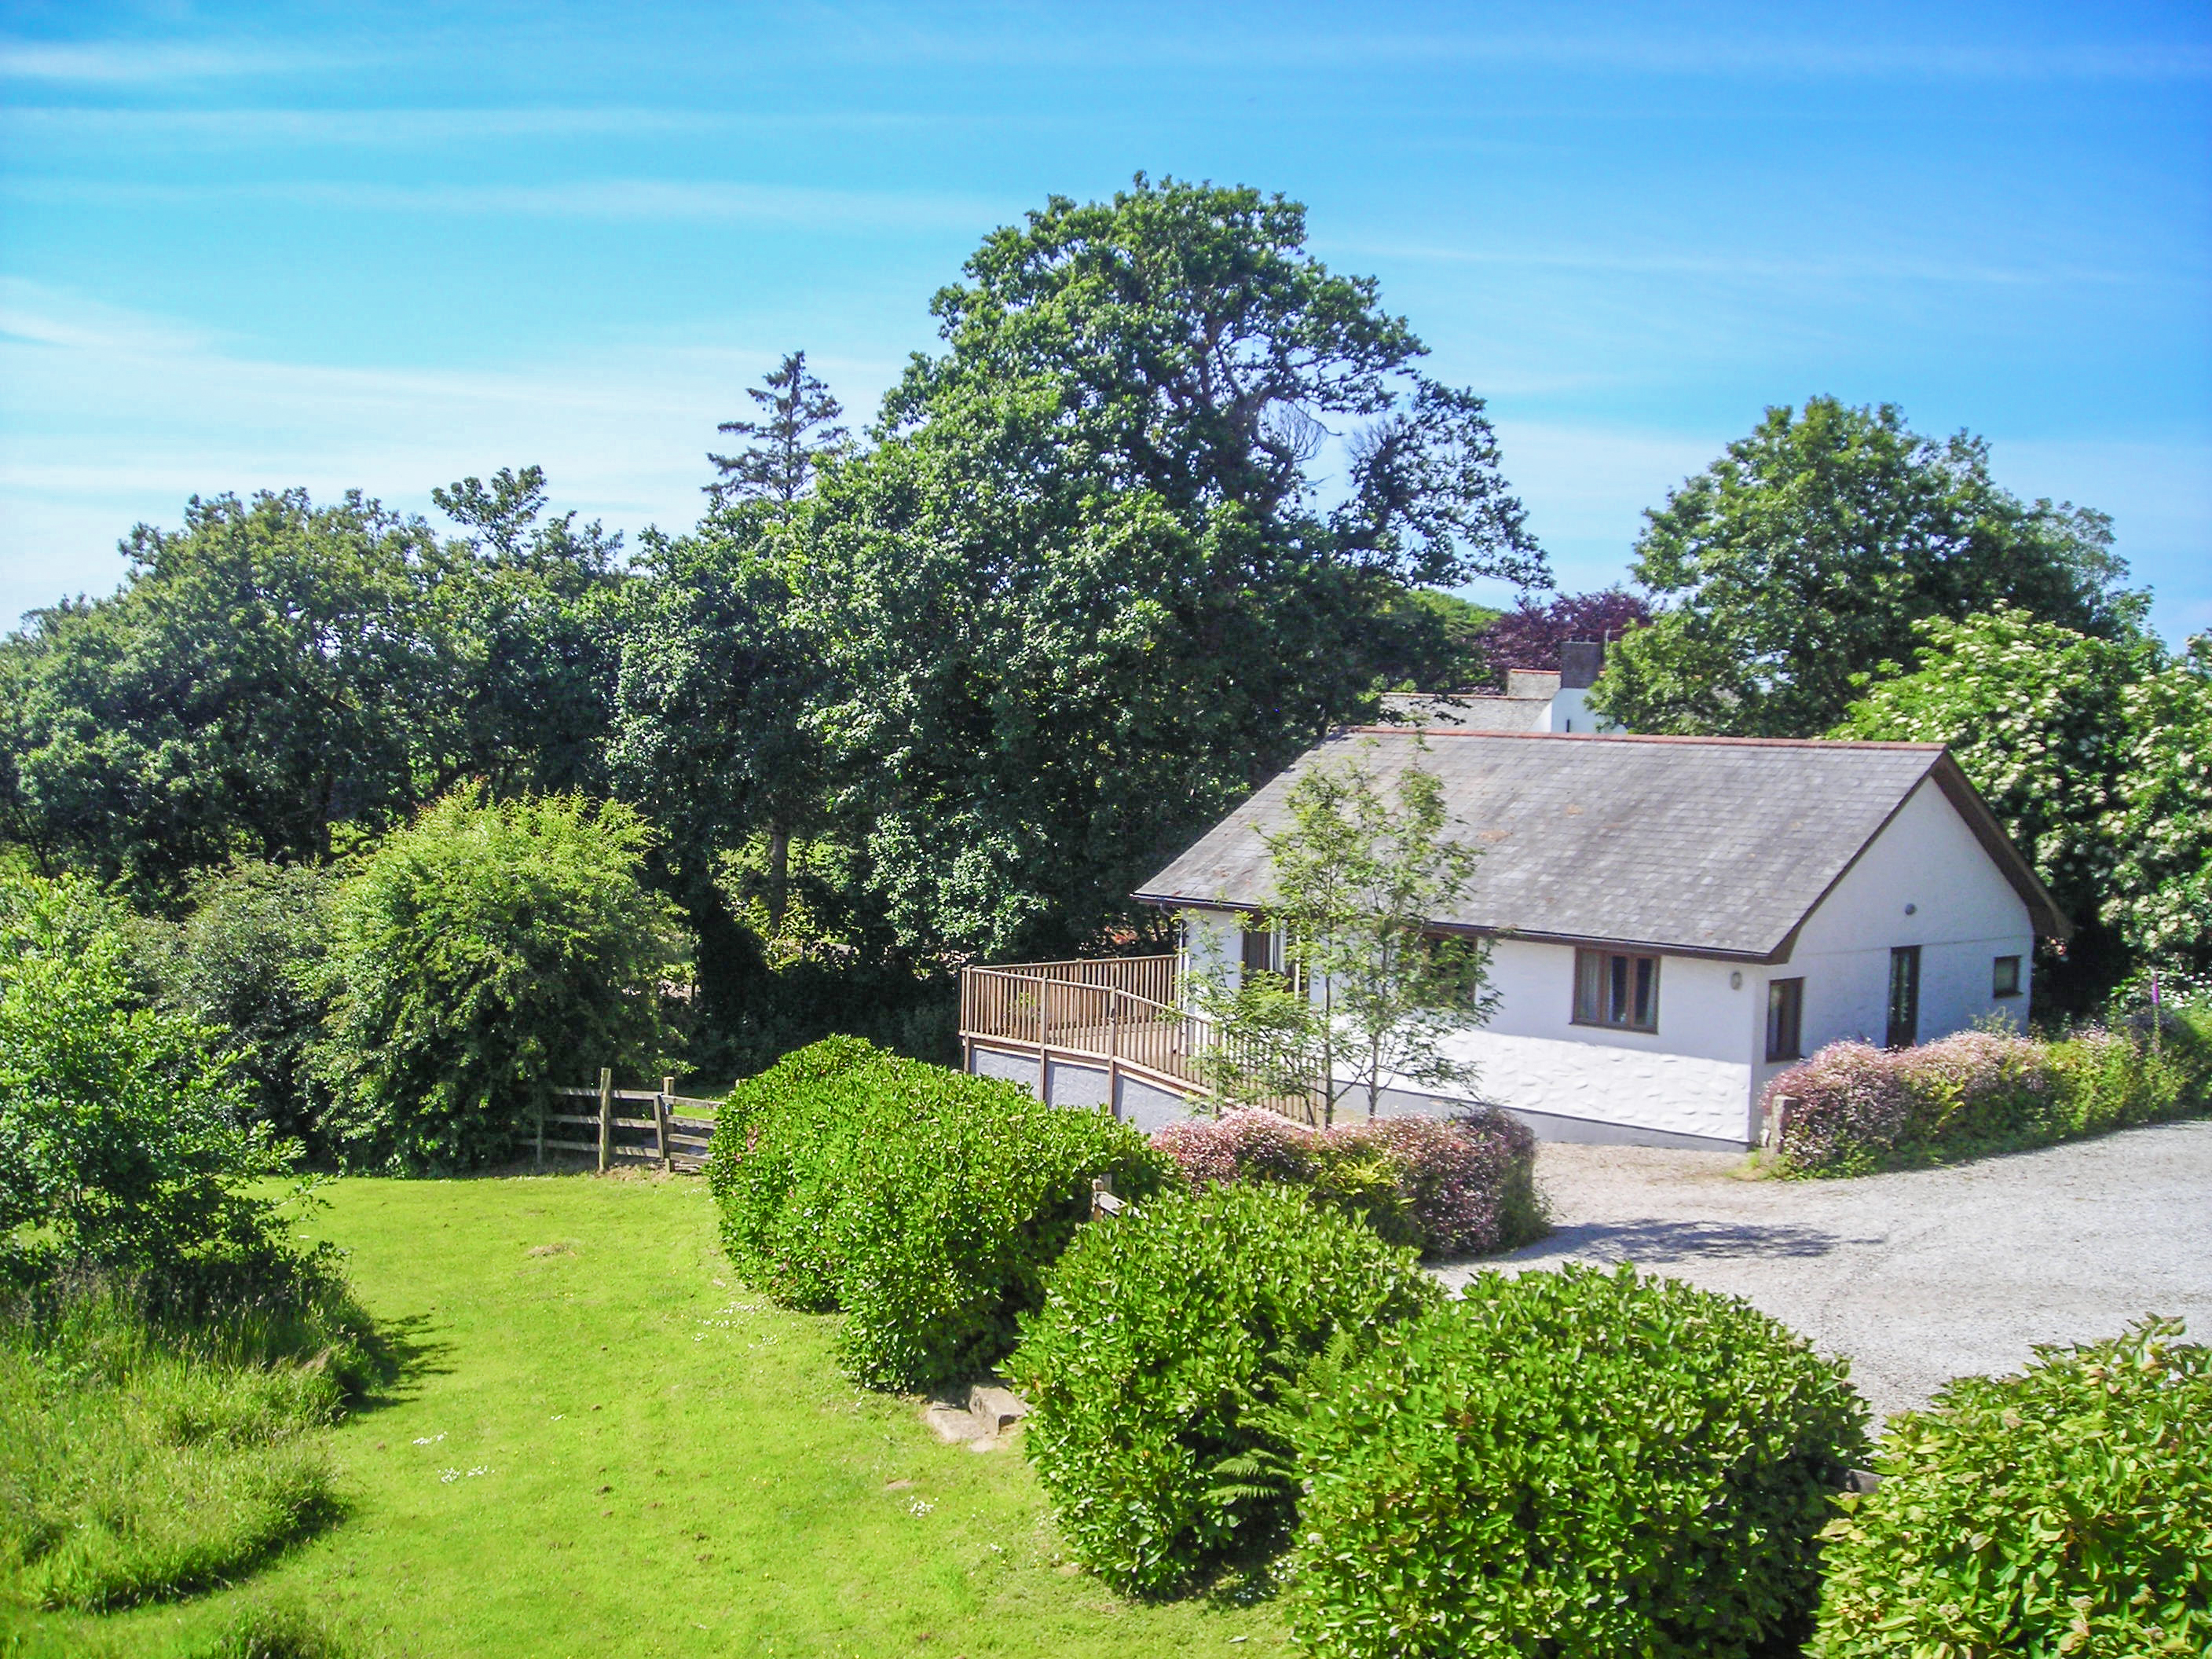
792, 174, 1544, 954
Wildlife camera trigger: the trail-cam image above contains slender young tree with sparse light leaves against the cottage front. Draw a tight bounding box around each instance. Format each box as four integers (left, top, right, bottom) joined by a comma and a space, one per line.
1190, 745, 1496, 1128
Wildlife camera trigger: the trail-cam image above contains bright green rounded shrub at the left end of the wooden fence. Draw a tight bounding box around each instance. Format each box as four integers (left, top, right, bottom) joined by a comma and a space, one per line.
317, 794, 679, 1170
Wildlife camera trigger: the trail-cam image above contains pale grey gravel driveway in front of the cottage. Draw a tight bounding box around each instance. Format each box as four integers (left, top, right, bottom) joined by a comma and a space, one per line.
1440, 1119, 2212, 1418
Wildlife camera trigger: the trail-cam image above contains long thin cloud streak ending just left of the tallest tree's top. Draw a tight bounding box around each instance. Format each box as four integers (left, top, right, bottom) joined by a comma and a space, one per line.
0, 177, 1017, 233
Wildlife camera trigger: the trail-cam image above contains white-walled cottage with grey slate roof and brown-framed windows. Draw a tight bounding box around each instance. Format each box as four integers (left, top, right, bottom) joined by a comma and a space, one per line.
1137, 734, 2068, 1148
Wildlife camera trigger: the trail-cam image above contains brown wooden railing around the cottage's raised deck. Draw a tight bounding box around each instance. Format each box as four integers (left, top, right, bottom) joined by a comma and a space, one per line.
960, 956, 1314, 1122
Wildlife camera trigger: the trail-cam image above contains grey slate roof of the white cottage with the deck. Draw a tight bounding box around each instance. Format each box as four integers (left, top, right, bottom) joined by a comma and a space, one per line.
1135, 726, 2073, 962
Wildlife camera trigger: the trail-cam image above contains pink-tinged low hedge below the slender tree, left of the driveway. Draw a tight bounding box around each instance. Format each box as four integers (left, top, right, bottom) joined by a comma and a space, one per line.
1152, 1108, 1546, 1256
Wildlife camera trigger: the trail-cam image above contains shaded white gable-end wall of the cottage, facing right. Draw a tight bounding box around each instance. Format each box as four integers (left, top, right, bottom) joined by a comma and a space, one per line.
1759, 783, 2035, 1082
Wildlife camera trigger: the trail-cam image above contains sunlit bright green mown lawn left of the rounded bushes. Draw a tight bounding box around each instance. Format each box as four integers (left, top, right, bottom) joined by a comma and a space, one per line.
0, 1174, 1285, 1659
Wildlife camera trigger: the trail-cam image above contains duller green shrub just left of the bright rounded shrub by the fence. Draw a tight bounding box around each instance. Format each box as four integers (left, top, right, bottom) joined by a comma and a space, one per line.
139, 860, 334, 1150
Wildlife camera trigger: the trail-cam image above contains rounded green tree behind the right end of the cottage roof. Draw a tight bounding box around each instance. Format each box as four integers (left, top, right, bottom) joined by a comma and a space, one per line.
1593, 398, 2144, 737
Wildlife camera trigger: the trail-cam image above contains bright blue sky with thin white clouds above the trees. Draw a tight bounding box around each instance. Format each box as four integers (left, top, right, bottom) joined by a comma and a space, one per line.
0, 0, 2212, 639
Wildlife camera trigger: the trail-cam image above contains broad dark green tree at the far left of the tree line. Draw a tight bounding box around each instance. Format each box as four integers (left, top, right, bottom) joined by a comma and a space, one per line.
0, 491, 469, 895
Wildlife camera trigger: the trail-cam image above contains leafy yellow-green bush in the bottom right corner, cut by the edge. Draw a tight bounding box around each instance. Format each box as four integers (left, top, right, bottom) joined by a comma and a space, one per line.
1811, 1318, 2212, 1659
